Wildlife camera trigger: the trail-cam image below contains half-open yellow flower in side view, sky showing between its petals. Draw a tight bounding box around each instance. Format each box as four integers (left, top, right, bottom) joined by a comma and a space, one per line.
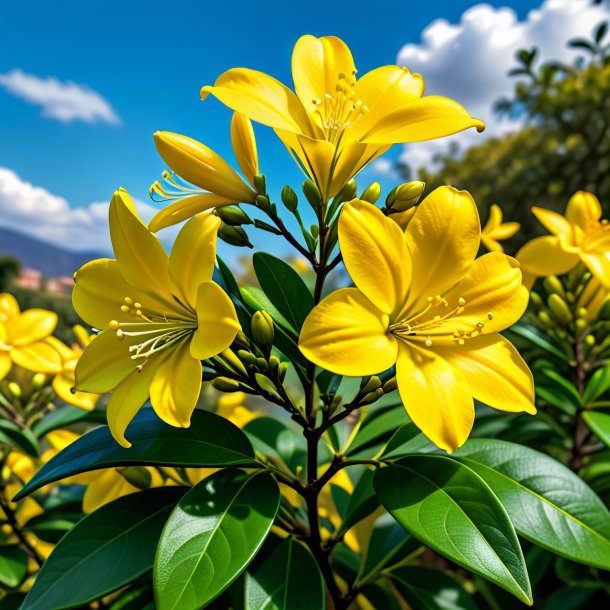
149, 112, 258, 232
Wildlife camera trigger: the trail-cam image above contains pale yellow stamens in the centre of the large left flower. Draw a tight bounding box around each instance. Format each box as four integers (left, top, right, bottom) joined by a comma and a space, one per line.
108, 297, 197, 371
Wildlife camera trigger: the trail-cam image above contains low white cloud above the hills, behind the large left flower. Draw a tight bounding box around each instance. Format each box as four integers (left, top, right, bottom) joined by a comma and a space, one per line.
0, 167, 176, 255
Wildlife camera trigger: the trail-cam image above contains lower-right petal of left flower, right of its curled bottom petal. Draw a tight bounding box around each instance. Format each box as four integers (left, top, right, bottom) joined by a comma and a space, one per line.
150, 341, 202, 428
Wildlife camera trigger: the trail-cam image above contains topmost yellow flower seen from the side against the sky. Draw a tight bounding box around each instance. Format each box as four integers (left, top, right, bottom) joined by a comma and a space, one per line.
201, 35, 484, 200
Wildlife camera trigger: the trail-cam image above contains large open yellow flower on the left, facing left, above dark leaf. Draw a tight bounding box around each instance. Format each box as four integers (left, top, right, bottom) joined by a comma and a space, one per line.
72, 189, 240, 447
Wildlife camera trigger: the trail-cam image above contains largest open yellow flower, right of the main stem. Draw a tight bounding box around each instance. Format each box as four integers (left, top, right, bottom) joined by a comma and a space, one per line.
299, 187, 535, 451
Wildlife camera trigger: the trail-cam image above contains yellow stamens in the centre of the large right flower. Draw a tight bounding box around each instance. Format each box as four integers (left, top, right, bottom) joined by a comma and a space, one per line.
388, 295, 493, 347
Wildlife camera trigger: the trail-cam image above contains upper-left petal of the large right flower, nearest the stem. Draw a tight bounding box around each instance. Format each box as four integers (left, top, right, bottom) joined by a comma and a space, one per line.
339, 199, 411, 314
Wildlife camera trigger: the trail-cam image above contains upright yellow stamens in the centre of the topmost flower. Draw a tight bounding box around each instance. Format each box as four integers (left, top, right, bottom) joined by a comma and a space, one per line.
311, 71, 368, 143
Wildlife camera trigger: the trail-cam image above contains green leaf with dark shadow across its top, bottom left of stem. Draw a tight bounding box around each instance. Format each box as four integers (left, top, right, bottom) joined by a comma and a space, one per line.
154, 468, 280, 610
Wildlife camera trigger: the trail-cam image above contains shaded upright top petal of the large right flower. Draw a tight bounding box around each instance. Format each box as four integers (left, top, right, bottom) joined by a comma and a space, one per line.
405, 186, 481, 312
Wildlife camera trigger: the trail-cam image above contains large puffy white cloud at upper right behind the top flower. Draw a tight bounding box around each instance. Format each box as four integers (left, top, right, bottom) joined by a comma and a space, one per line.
398, 0, 610, 167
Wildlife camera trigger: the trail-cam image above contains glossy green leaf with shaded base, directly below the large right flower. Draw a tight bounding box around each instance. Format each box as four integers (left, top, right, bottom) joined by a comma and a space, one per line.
375, 455, 532, 604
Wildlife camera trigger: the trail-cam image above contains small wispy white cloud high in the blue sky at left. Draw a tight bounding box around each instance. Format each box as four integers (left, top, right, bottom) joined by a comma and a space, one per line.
0, 69, 121, 125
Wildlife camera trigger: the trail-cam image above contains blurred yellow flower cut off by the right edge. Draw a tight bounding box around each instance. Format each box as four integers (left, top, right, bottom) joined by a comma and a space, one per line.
516, 191, 610, 288
